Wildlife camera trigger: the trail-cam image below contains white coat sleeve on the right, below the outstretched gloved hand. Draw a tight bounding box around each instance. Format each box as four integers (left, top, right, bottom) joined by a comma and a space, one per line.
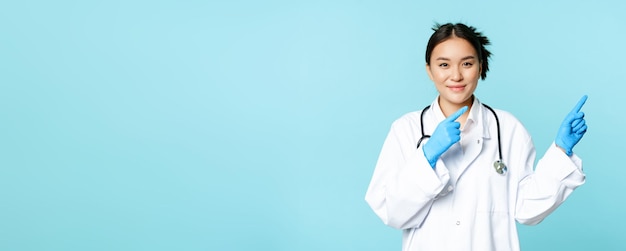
516, 142, 585, 225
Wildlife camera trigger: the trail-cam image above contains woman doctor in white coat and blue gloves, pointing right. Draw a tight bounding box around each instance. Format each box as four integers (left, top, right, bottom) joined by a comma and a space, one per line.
365, 24, 587, 251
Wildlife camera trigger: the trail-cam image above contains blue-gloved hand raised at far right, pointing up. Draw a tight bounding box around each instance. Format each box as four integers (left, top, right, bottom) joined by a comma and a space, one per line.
554, 95, 587, 156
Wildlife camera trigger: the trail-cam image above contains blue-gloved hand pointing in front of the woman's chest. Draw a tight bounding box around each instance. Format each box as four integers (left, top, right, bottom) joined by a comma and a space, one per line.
423, 106, 467, 168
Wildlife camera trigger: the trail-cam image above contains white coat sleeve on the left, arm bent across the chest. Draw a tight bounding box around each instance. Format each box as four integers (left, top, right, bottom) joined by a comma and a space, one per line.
365, 121, 450, 229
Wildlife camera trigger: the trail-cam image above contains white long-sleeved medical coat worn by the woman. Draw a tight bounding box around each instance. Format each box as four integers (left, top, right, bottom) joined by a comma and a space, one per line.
365, 98, 585, 251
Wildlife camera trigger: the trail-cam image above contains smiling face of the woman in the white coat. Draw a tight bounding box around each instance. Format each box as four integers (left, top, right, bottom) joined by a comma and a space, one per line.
426, 36, 481, 106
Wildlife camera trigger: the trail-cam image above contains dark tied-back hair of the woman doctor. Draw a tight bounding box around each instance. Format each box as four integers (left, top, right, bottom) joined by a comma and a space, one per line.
426, 23, 491, 80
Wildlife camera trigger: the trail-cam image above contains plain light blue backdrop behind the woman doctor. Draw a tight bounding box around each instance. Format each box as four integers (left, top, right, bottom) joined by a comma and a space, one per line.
0, 0, 626, 250
